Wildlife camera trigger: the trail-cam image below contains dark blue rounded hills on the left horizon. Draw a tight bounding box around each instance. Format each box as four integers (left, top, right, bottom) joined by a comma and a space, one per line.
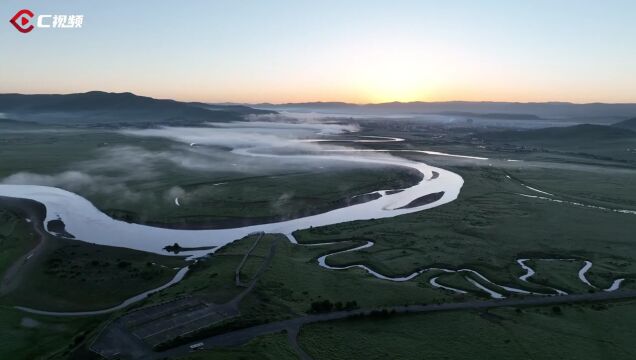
0, 91, 274, 126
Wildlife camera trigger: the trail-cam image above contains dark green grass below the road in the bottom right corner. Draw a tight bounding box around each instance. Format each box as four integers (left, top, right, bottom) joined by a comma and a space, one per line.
299, 301, 636, 360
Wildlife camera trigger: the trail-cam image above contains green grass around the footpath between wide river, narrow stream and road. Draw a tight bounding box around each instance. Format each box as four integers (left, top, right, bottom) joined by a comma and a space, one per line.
139, 235, 464, 334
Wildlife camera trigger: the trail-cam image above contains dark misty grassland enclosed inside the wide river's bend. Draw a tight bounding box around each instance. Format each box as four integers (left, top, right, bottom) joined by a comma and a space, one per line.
110, 167, 419, 228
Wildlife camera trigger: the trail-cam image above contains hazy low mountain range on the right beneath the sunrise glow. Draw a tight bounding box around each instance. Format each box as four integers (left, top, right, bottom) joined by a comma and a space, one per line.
252, 101, 636, 119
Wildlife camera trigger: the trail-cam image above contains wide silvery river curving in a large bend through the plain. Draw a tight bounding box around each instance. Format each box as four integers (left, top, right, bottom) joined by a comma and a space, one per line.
0, 149, 463, 256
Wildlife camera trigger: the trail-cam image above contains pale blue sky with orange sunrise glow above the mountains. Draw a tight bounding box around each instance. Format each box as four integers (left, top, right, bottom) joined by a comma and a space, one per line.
0, 0, 636, 103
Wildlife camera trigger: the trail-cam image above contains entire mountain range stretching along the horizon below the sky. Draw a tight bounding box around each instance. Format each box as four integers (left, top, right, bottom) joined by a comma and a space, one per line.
0, 91, 636, 126
